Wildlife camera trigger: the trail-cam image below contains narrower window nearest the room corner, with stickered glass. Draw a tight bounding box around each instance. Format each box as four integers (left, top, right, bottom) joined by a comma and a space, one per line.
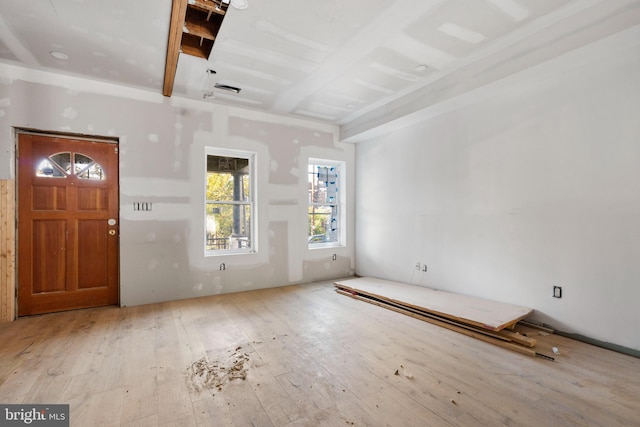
307, 159, 344, 248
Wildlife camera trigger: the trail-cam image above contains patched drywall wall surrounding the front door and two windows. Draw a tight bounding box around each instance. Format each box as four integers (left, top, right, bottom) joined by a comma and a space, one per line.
0, 65, 355, 305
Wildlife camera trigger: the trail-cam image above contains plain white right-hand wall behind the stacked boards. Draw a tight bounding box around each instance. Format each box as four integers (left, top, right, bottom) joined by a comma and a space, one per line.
356, 28, 640, 350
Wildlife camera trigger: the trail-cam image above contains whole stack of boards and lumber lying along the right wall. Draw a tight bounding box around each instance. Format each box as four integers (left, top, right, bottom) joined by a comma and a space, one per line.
335, 277, 553, 360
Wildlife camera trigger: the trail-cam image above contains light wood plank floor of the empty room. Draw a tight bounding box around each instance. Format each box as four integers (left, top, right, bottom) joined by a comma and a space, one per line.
0, 282, 640, 427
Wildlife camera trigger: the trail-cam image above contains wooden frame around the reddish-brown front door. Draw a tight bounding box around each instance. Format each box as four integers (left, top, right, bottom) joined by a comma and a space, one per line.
12, 127, 122, 320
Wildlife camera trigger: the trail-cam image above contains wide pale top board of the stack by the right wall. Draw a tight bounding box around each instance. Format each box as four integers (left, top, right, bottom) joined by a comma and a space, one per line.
334, 277, 533, 331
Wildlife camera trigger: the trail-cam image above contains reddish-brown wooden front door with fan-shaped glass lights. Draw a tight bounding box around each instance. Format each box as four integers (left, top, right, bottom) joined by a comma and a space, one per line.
17, 133, 119, 316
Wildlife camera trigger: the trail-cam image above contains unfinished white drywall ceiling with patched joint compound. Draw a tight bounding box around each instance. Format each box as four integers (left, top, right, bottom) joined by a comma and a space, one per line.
0, 0, 640, 137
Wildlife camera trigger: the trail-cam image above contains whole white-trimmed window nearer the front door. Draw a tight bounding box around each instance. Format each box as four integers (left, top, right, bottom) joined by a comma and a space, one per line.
205, 147, 256, 255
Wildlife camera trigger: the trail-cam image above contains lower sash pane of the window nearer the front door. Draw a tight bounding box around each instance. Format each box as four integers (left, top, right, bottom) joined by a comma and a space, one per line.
206, 203, 251, 250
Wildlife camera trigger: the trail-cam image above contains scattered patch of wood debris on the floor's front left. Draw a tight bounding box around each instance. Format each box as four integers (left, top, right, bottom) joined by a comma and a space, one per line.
187, 346, 249, 391
